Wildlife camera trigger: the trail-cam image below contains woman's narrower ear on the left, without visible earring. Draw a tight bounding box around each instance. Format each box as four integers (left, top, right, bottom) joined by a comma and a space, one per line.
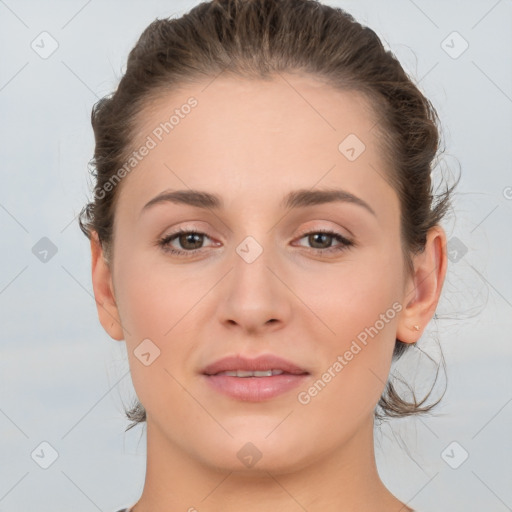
91, 231, 124, 341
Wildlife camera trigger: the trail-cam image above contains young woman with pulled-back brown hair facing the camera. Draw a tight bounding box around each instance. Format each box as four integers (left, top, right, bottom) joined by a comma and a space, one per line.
80, 0, 451, 512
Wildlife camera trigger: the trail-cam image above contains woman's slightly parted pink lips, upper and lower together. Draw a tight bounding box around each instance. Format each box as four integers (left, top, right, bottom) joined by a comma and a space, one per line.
202, 355, 310, 402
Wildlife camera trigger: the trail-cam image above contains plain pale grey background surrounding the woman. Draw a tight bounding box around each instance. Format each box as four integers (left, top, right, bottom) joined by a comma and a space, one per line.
0, 0, 512, 512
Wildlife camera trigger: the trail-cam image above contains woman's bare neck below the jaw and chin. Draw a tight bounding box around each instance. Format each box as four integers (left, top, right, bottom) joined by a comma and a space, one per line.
129, 418, 411, 512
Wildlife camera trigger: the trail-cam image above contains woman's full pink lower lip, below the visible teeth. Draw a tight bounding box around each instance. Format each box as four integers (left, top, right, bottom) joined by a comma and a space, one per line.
204, 373, 309, 402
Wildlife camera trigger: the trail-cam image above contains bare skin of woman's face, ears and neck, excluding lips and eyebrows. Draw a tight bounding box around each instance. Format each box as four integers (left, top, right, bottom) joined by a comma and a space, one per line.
91, 74, 447, 512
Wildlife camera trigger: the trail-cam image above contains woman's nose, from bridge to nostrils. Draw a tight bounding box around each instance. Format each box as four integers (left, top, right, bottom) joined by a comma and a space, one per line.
217, 237, 293, 335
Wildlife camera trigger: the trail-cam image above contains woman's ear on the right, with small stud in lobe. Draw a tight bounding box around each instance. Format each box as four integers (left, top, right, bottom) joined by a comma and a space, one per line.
396, 225, 448, 343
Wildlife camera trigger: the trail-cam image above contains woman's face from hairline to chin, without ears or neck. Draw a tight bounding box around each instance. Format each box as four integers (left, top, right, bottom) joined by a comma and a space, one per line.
99, 75, 416, 470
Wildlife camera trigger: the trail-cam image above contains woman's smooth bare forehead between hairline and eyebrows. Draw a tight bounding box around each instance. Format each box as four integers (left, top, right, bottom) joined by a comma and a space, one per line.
117, 74, 393, 221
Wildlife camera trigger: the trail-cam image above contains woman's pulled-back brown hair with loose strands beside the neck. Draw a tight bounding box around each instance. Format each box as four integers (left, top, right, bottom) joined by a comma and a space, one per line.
79, 0, 456, 428
